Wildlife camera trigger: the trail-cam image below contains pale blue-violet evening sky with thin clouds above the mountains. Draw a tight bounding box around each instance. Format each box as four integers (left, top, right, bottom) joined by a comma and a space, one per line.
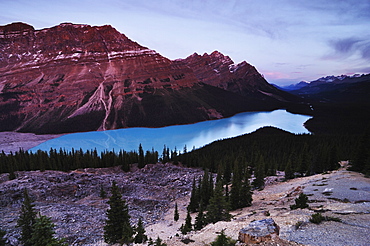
0, 0, 370, 85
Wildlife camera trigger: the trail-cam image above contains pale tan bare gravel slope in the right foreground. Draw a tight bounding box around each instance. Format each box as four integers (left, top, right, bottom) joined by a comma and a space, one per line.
147, 170, 370, 246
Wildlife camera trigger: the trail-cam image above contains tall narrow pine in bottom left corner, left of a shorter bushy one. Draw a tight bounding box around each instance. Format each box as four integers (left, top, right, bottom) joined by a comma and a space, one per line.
17, 189, 36, 246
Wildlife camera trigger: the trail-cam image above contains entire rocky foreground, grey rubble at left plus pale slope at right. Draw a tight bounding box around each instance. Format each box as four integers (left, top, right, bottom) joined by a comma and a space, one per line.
0, 164, 370, 246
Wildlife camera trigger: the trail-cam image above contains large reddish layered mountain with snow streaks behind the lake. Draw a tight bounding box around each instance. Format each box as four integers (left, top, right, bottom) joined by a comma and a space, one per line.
0, 23, 299, 134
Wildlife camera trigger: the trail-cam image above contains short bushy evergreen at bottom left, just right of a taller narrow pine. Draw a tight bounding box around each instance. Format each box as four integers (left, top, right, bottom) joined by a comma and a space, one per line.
30, 215, 67, 246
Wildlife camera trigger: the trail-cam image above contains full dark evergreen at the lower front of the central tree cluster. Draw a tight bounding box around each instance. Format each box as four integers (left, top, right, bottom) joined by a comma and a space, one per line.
206, 182, 231, 223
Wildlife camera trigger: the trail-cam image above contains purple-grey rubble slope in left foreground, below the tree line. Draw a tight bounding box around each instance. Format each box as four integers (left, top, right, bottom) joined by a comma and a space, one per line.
0, 164, 203, 245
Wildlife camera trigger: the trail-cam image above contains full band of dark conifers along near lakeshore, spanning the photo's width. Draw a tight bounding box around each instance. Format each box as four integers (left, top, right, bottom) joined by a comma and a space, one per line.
0, 127, 364, 181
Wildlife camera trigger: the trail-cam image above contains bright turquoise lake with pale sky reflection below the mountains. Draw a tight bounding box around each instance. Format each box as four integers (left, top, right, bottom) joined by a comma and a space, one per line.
31, 110, 311, 152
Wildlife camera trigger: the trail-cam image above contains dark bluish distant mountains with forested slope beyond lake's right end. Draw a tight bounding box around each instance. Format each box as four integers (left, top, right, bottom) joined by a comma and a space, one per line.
290, 74, 370, 135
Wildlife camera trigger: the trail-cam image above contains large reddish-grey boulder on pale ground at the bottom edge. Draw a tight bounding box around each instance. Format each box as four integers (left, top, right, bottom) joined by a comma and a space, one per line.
239, 218, 280, 244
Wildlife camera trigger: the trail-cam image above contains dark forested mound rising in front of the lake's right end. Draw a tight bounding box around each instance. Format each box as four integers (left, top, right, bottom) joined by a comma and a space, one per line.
178, 127, 359, 179
